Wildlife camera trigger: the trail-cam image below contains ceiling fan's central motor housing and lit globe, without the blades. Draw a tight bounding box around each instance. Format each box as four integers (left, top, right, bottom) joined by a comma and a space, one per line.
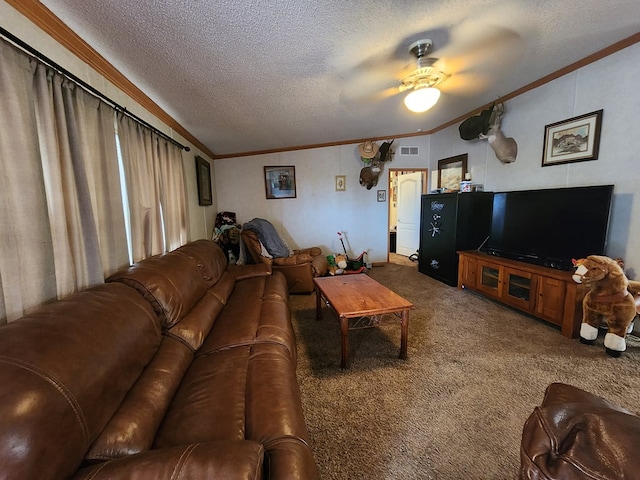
398, 39, 449, 113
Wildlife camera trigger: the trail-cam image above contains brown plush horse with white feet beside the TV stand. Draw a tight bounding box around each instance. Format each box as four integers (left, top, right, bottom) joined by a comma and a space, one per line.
573, 255, 640, 357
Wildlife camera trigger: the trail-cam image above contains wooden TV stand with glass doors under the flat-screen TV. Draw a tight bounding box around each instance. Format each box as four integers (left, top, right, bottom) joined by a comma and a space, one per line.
458, 250, 586, 338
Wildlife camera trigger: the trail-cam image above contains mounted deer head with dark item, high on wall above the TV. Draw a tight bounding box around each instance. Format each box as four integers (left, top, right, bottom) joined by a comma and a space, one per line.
459, 102, 518, 164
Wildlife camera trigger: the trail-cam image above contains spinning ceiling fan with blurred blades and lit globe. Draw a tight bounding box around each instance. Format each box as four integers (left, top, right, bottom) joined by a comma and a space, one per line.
343, 17, 525, 112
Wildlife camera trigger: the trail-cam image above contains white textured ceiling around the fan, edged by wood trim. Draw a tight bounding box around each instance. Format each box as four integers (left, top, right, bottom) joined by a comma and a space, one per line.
42, 0, 640, 156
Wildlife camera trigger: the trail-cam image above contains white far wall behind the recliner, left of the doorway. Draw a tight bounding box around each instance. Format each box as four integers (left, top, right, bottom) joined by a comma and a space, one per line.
214, 136, 429, 262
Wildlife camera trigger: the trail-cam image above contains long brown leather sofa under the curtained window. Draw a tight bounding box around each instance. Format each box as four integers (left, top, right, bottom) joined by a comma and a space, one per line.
0, 240, 317, 480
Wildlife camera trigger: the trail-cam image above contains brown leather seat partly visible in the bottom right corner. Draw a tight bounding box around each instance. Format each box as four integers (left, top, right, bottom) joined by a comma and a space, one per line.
520, 383, 640, 480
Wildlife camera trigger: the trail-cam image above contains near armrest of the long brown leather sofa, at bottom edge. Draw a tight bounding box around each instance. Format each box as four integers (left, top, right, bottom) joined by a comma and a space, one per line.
71, 440, 264, 480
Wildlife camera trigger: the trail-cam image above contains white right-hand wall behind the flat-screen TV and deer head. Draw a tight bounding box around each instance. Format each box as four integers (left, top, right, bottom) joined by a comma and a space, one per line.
430, 44, 640, 277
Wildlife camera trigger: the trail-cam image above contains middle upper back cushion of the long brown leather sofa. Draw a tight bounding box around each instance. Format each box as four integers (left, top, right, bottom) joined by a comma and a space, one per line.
107, 251, 210, 328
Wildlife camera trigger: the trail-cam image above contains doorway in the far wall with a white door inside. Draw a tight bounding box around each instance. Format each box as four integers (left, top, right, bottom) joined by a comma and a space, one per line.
387, 168, 429, 265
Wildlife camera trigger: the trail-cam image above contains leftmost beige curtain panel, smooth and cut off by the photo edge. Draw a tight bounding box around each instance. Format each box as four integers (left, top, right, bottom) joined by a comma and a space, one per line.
0, 42, 57, 324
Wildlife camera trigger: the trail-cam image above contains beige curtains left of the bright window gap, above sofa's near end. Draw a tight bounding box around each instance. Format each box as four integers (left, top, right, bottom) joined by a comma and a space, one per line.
0, 41, 128, 323
